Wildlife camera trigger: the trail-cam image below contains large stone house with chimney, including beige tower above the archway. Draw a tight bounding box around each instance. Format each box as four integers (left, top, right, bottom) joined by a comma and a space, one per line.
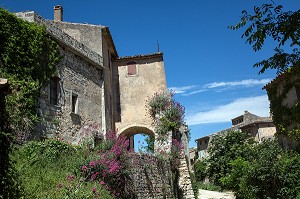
16, 6, 166, 143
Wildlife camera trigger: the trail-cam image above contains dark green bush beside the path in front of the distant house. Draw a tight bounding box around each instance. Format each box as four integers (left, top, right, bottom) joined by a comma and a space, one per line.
207, 131, 254, 185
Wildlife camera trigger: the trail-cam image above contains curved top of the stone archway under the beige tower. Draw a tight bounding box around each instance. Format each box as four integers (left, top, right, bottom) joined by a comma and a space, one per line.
118, 123, 156, 149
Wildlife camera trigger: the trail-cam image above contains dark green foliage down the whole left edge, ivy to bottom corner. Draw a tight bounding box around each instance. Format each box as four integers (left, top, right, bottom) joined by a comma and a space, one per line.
0, 8, 60, 198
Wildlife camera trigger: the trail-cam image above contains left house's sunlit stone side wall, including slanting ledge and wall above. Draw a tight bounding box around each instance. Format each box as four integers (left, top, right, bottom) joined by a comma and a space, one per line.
16, 11, 107, 141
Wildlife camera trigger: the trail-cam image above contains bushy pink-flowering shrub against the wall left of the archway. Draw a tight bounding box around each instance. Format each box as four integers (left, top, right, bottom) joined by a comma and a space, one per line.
81, 131, 130, 197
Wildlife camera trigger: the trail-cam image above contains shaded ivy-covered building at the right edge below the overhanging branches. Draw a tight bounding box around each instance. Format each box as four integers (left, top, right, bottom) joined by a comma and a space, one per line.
264, 68, 300, 148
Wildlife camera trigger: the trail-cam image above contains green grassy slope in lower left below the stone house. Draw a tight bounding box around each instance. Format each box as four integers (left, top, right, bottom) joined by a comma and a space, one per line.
10, 140, 113, 199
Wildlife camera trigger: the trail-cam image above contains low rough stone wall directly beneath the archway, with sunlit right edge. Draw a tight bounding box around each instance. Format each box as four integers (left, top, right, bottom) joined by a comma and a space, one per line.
126, 154, 195, 199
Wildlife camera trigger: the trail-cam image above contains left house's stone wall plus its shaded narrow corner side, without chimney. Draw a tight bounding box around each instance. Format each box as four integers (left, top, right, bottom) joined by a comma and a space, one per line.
16, 11, 117, 136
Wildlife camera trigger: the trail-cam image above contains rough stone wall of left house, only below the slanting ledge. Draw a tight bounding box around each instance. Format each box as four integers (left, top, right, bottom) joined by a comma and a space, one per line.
39, 50, 103, 142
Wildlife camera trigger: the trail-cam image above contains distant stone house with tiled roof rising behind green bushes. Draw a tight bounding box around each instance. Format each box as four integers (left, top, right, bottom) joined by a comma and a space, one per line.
195, 111, 276, 159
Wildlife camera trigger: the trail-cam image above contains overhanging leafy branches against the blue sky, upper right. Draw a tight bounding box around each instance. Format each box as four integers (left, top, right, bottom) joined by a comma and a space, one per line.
229, 4, 300, 73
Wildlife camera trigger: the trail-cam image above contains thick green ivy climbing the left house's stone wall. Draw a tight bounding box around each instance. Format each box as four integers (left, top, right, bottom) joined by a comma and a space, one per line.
0, 8, 60, 139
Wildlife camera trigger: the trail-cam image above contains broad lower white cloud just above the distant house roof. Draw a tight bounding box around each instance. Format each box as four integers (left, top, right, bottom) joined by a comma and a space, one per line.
186, 95, 269, 125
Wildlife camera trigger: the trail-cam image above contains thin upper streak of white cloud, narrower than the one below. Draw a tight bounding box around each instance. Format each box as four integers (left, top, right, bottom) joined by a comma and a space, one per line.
204, 79, 271, 88
